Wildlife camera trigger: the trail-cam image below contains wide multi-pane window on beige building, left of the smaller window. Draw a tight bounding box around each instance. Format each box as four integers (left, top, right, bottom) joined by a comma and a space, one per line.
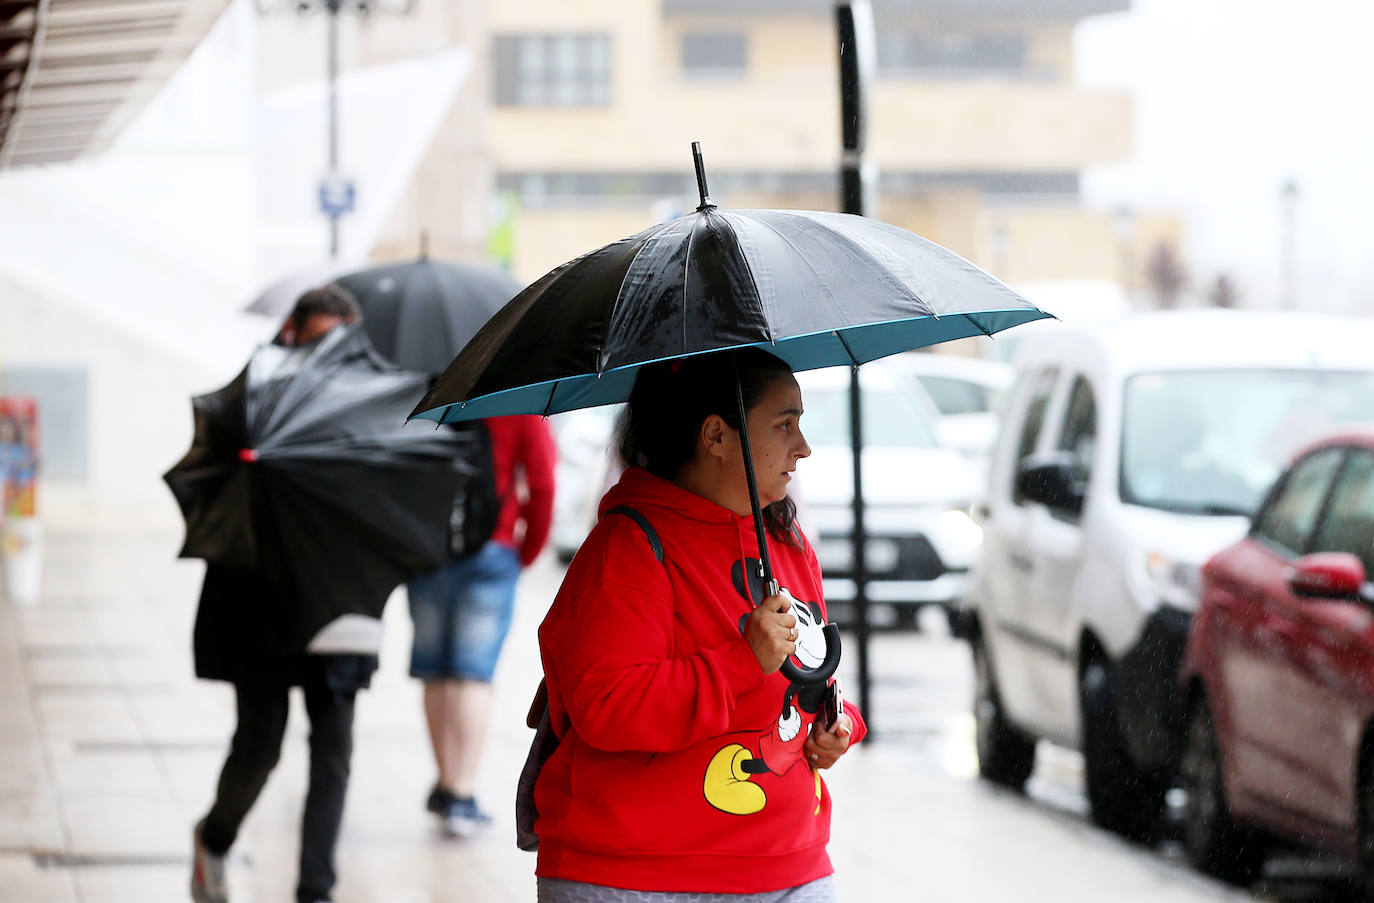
492, 34, 610, 107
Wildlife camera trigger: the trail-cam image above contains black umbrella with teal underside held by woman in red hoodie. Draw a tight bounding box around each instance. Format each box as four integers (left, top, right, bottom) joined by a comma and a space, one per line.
411, 146, 1048, 683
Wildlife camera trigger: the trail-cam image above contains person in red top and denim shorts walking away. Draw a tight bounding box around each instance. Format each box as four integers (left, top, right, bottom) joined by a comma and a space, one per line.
408, 415, 558, 837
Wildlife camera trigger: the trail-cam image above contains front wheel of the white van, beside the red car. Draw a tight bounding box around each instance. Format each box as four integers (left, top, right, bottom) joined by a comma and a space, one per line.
1079, 657, 1168, 843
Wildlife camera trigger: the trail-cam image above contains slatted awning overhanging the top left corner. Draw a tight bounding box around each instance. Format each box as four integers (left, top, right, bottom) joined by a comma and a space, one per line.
0, 0, 229, 169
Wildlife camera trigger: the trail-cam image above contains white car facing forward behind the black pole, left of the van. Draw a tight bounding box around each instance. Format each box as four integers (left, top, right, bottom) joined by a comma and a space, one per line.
796, 361, 982, 627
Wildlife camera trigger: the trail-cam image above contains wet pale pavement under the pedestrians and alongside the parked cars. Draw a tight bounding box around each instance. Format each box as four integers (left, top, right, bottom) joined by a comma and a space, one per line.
0, 528, 1349, 903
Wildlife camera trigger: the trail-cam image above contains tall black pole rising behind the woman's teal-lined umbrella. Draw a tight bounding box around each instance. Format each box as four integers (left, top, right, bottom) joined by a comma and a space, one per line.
835, 0, 877, 734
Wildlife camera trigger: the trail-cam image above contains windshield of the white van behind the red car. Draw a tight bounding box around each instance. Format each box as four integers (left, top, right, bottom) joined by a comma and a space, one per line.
1121, 370, 1374, 517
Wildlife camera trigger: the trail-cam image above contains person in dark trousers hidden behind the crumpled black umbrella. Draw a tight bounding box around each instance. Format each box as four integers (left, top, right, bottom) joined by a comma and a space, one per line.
191, 286, 370, 903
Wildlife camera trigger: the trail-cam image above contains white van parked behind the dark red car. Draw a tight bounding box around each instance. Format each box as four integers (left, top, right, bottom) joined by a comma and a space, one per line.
965, 311, 1374, 840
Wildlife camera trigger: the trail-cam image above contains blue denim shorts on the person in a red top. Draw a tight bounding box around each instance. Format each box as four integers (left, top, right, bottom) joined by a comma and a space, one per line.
407, 543, 519, 683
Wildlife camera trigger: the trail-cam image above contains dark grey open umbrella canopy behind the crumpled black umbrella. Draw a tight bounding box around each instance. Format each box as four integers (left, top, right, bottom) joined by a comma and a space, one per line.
334, 257, 522, 372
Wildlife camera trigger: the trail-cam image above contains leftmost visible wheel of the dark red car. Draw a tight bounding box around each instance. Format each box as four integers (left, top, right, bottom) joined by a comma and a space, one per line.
1179, 698, 1264, 884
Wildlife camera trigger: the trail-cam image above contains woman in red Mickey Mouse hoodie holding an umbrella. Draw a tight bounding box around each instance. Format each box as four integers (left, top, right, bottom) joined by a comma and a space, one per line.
534, 348, 864, 903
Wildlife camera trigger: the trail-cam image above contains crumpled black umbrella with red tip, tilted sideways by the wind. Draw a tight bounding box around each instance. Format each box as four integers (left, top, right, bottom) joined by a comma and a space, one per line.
164, 326, 463, 649
